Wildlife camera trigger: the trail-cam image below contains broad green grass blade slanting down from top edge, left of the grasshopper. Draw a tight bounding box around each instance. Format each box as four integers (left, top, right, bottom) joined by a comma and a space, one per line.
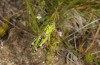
25, 0, 39, 35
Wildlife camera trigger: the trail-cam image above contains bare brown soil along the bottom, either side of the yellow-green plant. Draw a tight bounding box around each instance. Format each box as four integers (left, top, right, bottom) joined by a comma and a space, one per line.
0, 28, 83, 65
